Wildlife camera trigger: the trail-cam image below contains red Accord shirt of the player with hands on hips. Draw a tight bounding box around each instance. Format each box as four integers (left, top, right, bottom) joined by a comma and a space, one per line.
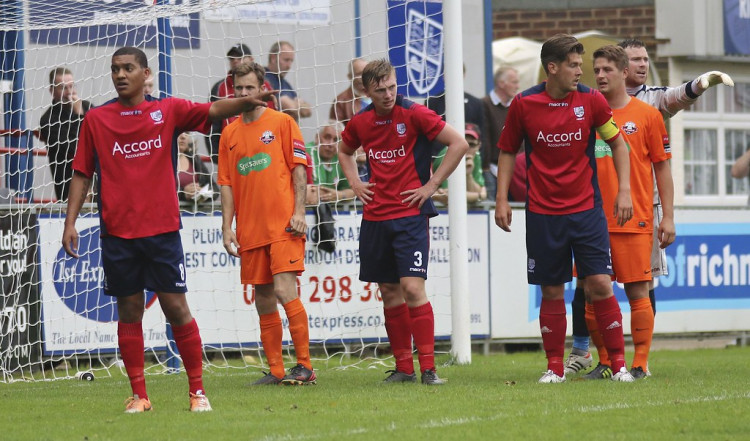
341, 95, 445, 221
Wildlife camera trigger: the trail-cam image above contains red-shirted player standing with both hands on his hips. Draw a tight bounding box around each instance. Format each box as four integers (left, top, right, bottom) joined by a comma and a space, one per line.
339, 60, 469, 385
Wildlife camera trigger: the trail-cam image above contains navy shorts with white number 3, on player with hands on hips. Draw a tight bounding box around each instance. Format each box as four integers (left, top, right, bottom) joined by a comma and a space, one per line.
359, 215, 430, 283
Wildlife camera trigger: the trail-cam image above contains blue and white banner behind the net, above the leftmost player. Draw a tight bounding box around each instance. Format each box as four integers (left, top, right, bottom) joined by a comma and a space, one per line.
29, 0, 200, 49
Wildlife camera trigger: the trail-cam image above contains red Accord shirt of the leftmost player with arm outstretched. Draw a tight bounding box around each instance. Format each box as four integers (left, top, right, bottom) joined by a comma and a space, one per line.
73, 96, 211, 239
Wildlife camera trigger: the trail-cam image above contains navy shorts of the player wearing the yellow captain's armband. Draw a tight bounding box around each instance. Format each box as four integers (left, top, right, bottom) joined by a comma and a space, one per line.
526, 207, 612, 285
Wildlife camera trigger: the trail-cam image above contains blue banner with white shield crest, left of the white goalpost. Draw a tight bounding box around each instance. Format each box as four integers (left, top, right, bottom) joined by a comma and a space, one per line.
388, 0, 445, 97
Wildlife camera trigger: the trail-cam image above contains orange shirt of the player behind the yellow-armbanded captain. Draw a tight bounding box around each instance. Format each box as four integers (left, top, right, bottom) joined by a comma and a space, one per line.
596, 98, 672, 234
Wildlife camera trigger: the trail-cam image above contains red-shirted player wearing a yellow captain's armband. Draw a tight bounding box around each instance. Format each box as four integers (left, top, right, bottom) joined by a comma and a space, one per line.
495, 34, 633, 383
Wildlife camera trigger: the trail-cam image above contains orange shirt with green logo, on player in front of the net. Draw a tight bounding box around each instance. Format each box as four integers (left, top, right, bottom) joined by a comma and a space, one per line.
218, 109, 307, 252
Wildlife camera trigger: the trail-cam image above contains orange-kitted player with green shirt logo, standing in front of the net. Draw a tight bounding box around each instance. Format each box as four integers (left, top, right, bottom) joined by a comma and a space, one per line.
218, 63, 316, 385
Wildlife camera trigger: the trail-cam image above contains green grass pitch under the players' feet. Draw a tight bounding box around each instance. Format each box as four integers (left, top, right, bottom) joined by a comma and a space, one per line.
0, 348, 750, 441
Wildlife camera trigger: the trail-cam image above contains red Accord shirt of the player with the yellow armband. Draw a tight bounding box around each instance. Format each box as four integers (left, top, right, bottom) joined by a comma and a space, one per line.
498, 83, 619, 215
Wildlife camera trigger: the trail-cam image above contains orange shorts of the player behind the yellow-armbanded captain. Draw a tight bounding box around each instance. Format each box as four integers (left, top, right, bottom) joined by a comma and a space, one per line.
609, 233, 654, 283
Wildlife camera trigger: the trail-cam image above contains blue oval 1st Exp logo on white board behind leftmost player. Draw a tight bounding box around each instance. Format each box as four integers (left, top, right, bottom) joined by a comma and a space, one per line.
52, 227, 156, 323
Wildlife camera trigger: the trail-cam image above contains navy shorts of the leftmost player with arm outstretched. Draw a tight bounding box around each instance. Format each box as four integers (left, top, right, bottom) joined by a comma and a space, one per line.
101, 231, 187, 297
